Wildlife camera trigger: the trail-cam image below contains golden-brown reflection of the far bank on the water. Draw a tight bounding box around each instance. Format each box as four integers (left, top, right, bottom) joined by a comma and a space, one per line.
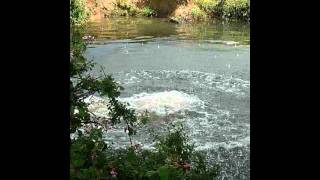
87, 17, 250, 44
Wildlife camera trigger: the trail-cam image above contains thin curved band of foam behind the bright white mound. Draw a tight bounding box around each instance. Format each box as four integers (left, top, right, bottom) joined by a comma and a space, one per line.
115, 70, 250, 96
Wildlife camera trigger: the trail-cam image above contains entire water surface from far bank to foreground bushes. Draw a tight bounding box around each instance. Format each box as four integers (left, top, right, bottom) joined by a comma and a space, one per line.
86, 18, 250, 179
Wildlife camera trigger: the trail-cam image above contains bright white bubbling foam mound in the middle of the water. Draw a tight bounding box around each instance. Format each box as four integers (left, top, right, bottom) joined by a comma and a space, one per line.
85, 90, 204, 117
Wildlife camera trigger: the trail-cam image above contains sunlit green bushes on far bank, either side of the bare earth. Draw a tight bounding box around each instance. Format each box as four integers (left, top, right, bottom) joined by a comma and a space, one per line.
107, 0, 250, 22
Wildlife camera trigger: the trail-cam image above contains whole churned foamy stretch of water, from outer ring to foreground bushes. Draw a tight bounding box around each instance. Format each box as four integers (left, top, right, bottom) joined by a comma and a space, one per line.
81, 70, 250, 179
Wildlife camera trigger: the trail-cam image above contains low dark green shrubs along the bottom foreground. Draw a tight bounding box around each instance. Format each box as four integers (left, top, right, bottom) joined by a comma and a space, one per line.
70, 122, 219, 180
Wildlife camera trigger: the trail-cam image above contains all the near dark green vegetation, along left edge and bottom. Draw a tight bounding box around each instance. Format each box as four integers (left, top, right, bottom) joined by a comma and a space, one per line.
70, 0, 219, 180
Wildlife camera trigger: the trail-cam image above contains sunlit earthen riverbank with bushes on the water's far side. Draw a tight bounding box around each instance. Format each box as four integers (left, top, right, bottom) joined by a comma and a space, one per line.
87, 0, 250, 23
